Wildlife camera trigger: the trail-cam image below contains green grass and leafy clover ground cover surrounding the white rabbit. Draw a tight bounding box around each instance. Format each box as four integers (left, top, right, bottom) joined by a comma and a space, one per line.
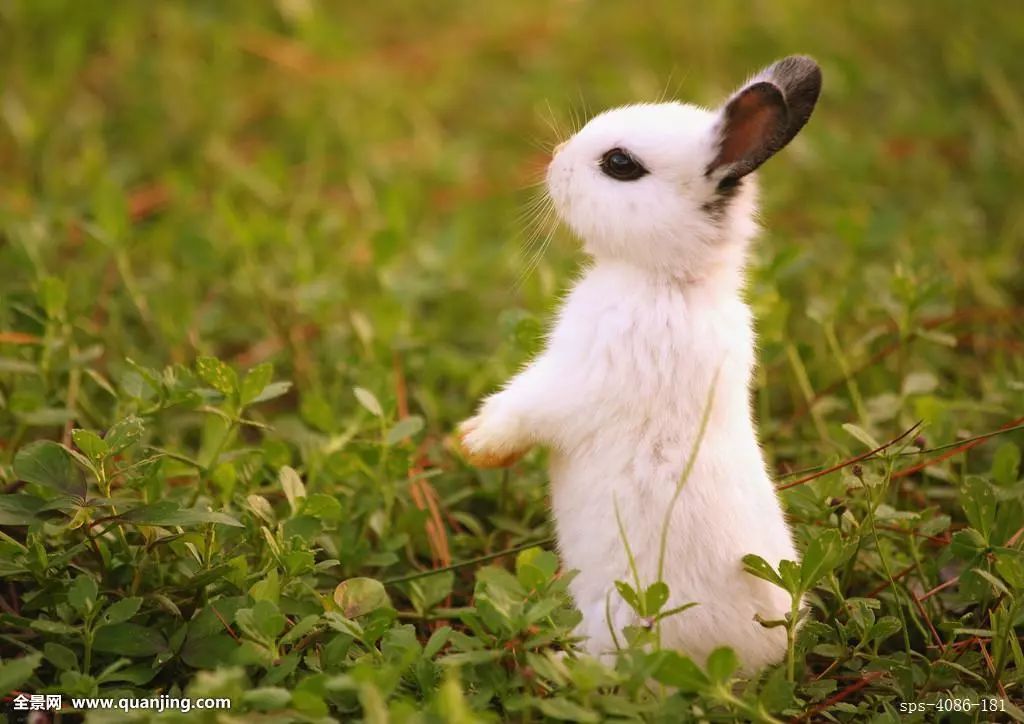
0, 0, 1024, 722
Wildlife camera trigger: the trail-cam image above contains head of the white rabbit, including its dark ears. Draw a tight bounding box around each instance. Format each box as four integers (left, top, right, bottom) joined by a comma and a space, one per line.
547, 55, 821, 279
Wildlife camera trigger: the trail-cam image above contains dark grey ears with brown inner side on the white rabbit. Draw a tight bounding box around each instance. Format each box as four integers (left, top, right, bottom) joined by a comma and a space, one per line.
707, 55, 821, 182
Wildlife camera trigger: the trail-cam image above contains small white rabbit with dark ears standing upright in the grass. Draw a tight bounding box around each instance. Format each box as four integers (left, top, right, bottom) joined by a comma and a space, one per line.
461, 56, 821, 671
